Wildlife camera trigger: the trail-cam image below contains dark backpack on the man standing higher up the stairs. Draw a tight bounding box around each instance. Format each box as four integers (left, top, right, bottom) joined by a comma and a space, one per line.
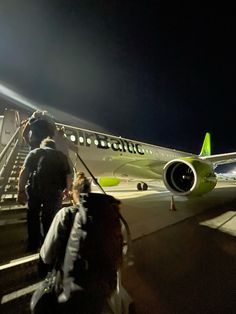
31, 148, 69, 193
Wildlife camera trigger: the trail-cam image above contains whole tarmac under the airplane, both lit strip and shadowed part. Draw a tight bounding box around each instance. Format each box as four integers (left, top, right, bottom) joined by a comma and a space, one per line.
1, 182, 236, 314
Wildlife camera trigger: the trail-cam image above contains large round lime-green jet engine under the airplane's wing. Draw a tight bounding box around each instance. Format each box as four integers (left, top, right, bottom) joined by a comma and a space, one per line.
163, 157, 217, 197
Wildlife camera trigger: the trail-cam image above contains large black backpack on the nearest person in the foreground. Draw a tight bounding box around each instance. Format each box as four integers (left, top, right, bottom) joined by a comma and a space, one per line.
59, 193, 123, 297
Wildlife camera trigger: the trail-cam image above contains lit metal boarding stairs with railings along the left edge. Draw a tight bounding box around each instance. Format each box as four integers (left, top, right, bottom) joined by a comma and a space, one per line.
0, 122, 133, 314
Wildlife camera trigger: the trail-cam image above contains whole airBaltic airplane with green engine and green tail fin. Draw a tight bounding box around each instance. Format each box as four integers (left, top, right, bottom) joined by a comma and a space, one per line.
57, 123, 236, 198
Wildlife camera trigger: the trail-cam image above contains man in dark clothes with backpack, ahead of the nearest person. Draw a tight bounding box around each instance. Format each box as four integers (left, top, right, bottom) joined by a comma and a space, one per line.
17, 138, 72, 251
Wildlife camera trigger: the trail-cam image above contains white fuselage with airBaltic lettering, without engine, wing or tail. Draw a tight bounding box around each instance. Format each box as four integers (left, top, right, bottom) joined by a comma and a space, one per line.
61, 125, 194, 179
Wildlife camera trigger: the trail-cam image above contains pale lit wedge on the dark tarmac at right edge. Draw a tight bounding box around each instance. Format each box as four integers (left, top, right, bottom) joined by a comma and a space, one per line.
200, 211, 236, 237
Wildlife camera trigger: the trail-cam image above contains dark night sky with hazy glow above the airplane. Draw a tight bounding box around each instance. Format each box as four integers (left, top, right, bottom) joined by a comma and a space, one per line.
0, 0, 236, 153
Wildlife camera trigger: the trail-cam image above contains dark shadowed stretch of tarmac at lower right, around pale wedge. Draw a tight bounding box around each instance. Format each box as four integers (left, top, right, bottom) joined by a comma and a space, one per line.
123, 203, 236, 314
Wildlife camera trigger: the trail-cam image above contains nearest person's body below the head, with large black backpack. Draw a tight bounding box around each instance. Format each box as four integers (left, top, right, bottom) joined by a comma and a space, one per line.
31, 193, 126, 314
